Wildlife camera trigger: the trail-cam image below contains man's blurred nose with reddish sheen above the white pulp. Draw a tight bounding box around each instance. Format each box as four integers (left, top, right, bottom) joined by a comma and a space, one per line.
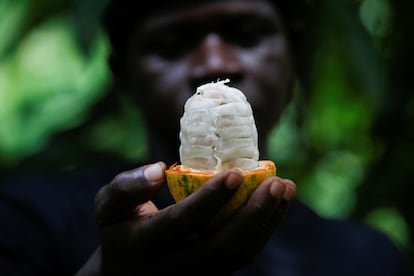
191, 33, 241, 82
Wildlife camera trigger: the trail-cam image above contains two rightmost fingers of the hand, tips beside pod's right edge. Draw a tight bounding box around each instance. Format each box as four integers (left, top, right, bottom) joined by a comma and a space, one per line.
160, 177, 296, 270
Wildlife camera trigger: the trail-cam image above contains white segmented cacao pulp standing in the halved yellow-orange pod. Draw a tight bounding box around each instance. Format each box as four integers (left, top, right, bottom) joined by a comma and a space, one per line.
180, 80, 259, 172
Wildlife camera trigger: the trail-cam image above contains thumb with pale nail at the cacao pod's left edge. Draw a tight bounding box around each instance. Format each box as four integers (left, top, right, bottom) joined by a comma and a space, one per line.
95, 162, 166, 226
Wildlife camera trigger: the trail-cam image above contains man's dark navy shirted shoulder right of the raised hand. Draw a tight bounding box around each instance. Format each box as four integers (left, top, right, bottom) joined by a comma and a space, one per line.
239, 202, 414, 276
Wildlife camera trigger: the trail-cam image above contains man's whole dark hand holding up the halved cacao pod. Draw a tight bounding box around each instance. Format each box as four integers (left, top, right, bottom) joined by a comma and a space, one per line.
77, 162, 296, 275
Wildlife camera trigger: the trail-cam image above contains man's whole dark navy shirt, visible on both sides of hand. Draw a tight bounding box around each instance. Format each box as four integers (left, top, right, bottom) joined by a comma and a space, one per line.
0, 164, 414, 276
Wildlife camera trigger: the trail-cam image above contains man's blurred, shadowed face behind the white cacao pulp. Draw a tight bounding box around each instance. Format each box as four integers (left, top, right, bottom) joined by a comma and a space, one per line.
118, 0, 294, 154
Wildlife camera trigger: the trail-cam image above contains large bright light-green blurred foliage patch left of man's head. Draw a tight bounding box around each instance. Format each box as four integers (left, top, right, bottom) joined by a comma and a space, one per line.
0, 12, 110, 165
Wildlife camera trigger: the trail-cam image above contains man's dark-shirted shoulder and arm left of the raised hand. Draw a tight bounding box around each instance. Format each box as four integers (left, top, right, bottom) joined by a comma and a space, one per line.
0, 164, 132, 274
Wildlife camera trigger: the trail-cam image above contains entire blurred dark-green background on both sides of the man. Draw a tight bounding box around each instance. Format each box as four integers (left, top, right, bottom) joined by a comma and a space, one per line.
0, 0, 414, 259
